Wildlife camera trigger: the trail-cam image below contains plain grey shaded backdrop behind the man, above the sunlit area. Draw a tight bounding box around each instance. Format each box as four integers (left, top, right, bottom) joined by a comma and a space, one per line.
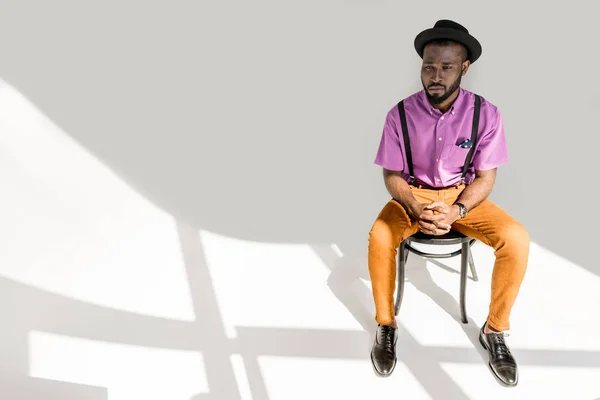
0, 0, 600, 280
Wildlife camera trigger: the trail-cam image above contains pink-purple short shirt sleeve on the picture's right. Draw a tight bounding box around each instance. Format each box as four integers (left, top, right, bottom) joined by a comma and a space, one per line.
473, 109, 508, 171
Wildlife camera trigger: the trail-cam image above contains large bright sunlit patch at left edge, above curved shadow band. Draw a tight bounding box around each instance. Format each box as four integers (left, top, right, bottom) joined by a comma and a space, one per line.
0, 82, 194, 320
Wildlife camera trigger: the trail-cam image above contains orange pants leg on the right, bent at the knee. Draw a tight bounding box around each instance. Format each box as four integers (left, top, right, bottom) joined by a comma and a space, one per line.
449, 199, 530, 331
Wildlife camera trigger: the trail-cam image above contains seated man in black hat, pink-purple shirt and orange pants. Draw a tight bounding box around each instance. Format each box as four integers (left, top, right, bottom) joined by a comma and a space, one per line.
368, 20, 529, 386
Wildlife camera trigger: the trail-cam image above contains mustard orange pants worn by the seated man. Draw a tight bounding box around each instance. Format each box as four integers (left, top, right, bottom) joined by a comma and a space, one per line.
369, 184, 530, 331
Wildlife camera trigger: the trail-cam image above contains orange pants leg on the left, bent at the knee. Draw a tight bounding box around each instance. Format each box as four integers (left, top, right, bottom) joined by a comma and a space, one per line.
368, 188, 437, 325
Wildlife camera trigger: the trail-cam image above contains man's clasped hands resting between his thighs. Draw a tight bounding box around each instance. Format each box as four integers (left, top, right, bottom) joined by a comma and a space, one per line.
411, 201, 460, 236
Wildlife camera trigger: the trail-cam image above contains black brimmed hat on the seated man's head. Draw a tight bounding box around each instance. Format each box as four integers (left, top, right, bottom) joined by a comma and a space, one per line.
415, 19, 482, 64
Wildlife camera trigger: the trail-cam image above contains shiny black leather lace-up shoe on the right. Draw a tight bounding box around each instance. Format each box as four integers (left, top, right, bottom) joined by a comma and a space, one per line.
479, 324, 519, 386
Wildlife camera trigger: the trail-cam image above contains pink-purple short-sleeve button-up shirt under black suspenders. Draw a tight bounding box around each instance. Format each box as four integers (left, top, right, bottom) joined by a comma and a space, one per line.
375, 88, 508, 187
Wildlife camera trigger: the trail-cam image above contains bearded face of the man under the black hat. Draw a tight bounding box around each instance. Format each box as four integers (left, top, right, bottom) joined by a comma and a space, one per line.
421, 43, 469, 104
